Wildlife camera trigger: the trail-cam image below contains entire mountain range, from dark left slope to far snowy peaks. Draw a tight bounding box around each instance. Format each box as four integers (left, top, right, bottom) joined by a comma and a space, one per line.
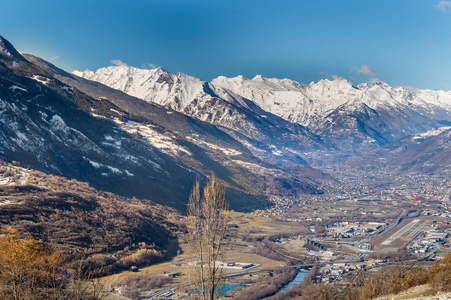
0, 33, 451, 210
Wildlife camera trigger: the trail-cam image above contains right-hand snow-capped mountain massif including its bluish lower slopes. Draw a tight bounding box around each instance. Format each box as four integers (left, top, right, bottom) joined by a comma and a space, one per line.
212, 76, 451, 152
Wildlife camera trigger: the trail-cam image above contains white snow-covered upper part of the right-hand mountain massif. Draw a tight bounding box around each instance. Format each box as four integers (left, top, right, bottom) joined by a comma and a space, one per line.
212, 75, 451, 127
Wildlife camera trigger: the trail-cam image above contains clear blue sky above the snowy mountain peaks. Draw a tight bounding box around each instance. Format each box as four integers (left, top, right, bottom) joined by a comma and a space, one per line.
0, 0, 451, 90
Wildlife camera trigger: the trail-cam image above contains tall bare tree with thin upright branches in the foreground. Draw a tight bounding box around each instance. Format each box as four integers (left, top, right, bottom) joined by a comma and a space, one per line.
187, 175, 228, 299
